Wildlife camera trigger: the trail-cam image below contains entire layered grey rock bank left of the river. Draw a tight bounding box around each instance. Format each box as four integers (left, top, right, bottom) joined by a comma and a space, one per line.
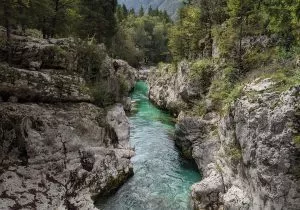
0, 32, 137, 210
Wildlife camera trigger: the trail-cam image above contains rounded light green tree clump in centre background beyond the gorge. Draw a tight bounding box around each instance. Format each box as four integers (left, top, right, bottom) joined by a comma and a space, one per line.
112, 13, 169, 66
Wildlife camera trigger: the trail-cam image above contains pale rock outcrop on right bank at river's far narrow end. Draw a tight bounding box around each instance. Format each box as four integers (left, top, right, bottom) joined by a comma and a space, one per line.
147, 62, 201, 115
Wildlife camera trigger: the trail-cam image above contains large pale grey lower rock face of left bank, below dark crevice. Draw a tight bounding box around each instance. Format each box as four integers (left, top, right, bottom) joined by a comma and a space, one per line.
0, 103, 133, 210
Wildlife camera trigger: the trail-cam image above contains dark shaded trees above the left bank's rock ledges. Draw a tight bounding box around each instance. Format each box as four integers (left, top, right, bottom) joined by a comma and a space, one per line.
0, 0, 117, 42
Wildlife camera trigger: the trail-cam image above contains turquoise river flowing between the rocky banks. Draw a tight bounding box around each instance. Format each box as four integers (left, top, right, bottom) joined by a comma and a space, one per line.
96, 82, 200, 210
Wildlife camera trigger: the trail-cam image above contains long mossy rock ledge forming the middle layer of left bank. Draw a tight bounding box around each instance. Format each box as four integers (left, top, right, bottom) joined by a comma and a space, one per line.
0, 65, 92, 102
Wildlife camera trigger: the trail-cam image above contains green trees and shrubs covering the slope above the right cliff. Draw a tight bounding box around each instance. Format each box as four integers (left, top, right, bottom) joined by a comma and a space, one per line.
168, 0, 300, 114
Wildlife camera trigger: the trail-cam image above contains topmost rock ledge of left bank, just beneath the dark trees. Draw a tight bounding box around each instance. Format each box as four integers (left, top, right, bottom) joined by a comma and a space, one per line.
0, 35, 78, 71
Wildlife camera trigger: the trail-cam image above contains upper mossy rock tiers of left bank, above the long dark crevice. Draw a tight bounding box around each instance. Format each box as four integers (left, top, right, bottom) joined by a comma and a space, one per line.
0, 35, 138, 106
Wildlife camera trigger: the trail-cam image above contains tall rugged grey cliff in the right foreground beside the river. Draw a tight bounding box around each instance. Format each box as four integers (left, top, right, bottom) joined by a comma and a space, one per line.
176, 79, 300, 210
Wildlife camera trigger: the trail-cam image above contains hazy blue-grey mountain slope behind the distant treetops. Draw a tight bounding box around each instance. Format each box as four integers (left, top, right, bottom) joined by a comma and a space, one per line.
118, 0, 182, 19
